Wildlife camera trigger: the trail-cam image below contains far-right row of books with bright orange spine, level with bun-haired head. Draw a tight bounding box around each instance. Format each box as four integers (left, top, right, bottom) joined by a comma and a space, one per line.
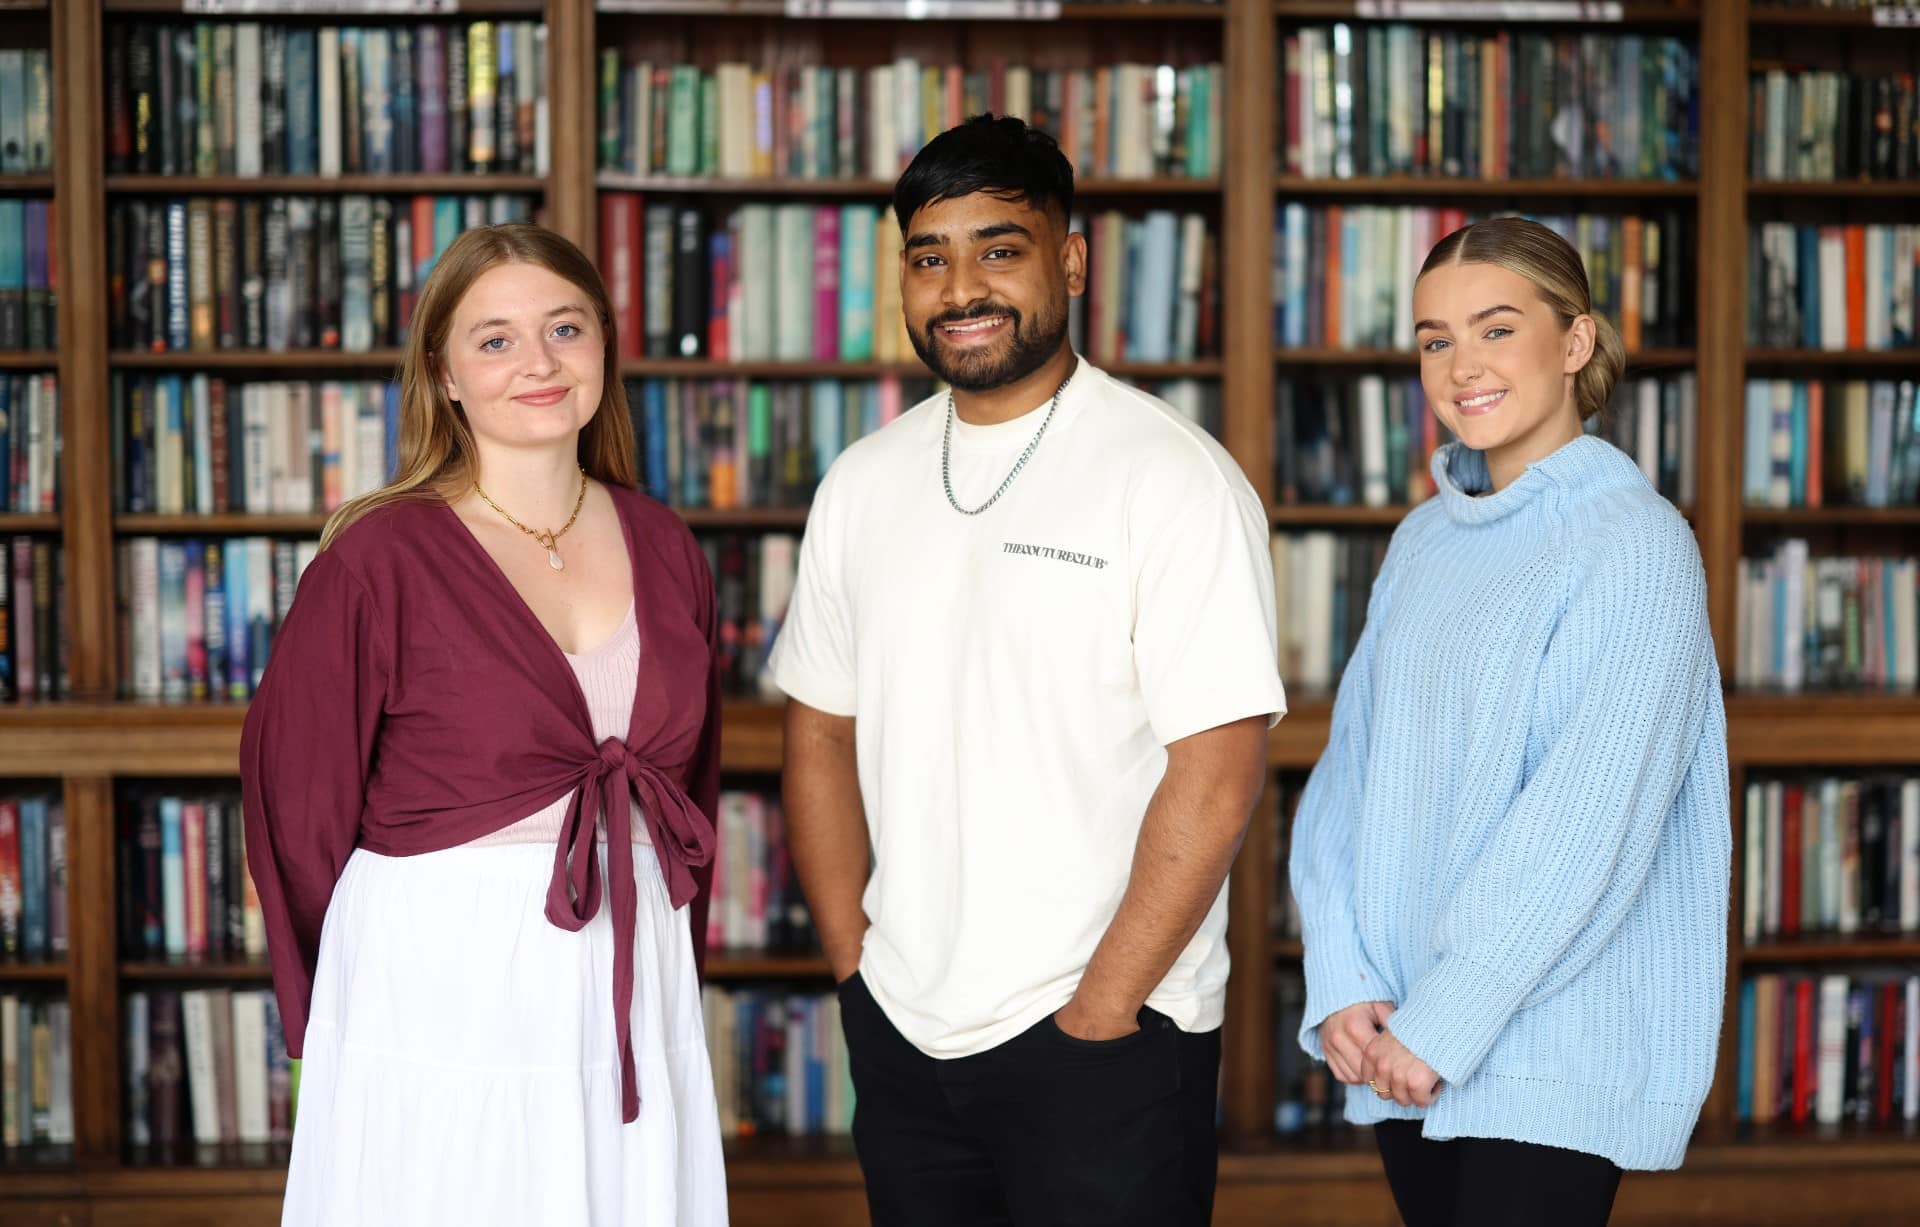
1747, 221, 1920, 349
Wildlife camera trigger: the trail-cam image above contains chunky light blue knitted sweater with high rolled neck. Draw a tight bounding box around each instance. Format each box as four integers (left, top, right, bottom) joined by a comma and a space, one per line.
1292, 436, 1732, 1167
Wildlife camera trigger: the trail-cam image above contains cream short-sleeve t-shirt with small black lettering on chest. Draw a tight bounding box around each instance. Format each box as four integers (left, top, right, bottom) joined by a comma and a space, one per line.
772, 359, 1286, 1058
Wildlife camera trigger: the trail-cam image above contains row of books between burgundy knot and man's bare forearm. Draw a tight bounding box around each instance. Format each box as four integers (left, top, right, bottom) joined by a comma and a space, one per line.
707, 791, 820, 954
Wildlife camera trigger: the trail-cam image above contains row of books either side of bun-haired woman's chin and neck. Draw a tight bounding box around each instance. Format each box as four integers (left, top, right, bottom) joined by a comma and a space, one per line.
1273, 371, 1699, 507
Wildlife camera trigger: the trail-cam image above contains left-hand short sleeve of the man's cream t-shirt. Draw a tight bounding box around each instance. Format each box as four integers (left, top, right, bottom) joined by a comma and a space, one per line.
770, 470, 858, 716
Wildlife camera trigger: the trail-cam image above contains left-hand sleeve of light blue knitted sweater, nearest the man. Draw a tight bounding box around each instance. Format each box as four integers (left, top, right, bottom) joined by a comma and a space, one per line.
1288, 557, 1394, 1060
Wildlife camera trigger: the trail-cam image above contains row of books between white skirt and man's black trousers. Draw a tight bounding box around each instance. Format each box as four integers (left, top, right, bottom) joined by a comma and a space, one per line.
701, 983, 852, 1137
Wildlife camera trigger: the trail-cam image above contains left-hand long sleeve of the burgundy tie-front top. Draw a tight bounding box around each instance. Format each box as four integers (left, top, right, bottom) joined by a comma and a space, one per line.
240, 553, 392, 1056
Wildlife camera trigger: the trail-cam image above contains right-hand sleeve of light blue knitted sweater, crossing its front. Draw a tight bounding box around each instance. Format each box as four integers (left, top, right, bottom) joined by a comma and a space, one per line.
1388, 518, 1718, 1085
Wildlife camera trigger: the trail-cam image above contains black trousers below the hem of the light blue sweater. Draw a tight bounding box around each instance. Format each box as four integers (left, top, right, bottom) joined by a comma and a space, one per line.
1373, 1121, 1620, 1227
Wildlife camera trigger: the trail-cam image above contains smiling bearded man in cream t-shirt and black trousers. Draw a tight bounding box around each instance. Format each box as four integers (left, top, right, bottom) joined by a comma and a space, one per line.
772, 115, 1286, 1227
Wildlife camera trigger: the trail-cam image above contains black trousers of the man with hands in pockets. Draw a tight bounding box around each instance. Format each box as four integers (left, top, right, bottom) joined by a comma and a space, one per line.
841, 975, 1219, 1227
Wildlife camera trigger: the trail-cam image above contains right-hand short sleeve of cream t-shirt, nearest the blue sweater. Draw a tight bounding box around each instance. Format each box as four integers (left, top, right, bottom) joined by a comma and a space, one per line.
1133, 488, 1286, 745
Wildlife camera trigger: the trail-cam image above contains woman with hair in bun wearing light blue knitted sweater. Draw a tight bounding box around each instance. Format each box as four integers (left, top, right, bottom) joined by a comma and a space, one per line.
1290, 217, 1730, 1227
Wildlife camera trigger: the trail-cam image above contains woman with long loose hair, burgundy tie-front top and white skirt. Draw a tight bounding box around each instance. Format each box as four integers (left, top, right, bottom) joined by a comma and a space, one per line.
240, 225, 726, 1227
